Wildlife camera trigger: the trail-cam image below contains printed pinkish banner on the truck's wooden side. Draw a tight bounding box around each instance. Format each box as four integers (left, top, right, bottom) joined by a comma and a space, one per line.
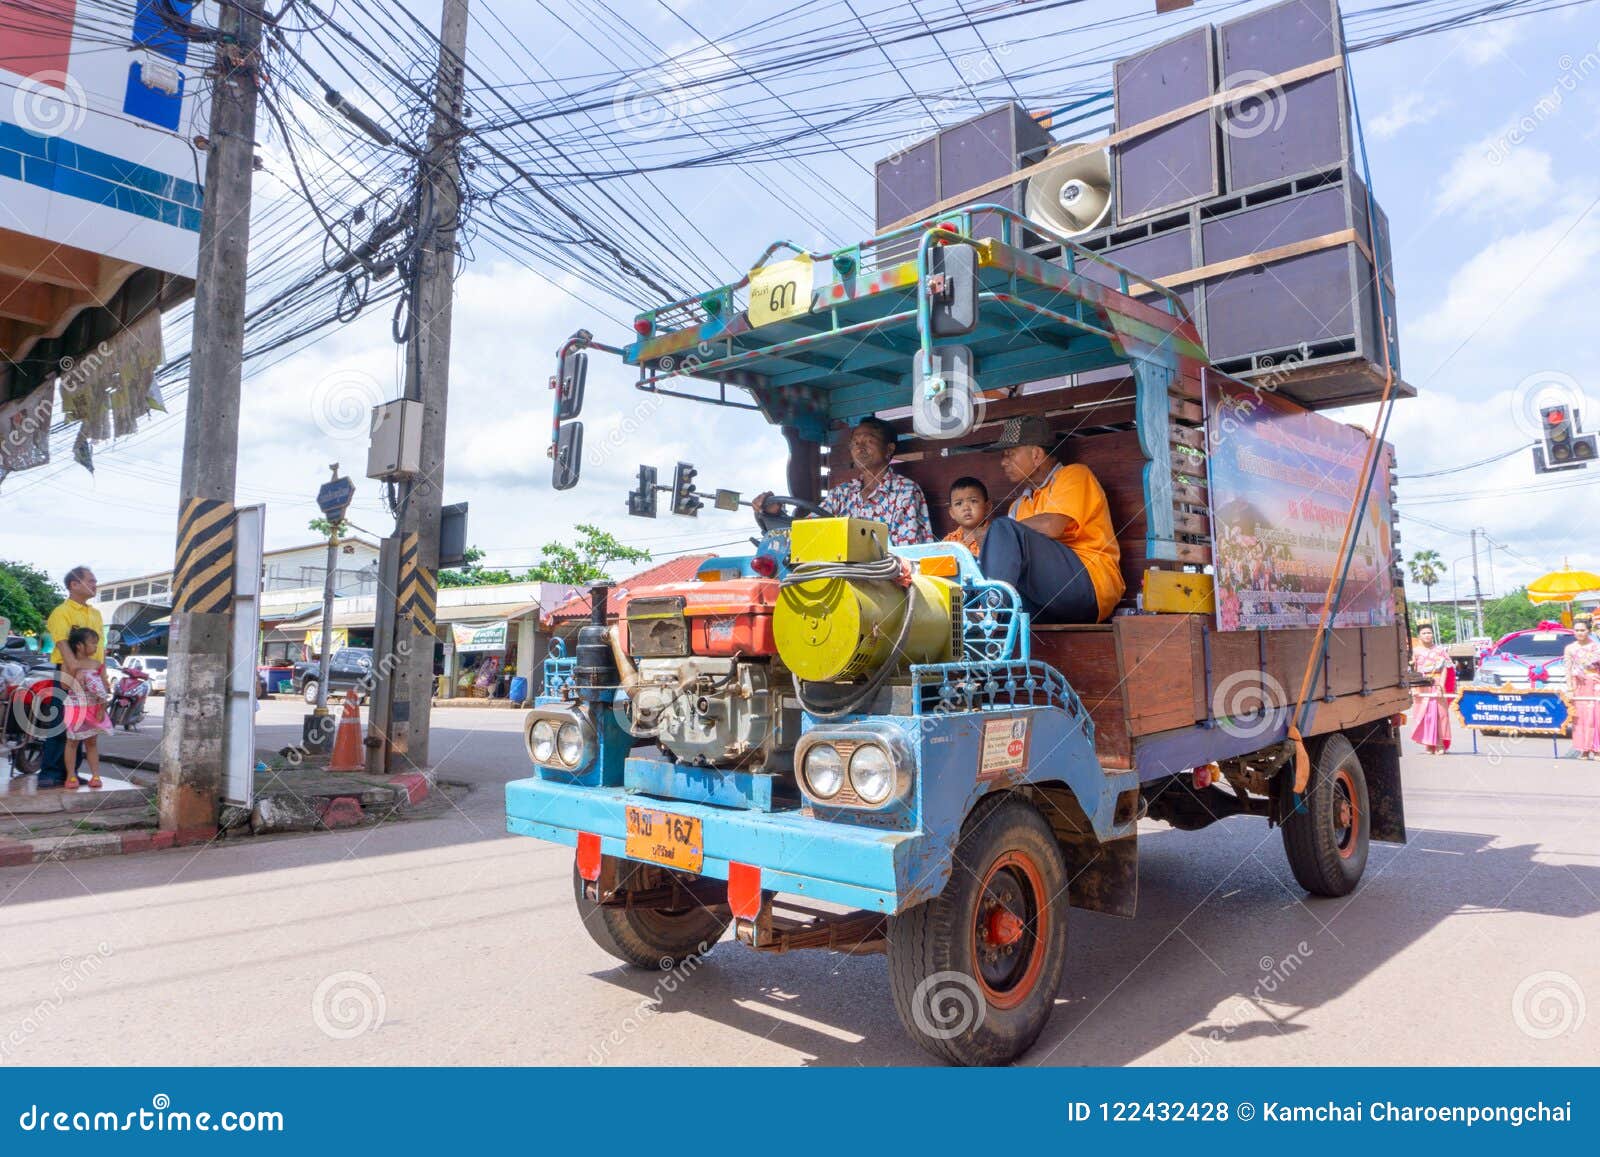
1206, 373, 1395, 631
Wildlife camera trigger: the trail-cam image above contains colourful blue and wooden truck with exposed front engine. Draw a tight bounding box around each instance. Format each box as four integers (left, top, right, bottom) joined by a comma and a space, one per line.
506, 206, 1410, 1064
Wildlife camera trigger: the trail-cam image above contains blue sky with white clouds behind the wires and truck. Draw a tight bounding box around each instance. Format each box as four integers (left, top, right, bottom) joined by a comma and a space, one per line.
0, 0, 1600, 611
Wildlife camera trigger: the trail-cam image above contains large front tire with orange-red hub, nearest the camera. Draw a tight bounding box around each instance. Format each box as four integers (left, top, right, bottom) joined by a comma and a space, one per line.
888, 795, 1067, 1064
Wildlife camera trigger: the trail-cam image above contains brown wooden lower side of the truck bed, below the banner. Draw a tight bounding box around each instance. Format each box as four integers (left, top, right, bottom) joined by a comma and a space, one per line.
1034, 615, 1410, 778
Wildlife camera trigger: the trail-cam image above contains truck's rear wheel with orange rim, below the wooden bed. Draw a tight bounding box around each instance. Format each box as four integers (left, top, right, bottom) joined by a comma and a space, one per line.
1283, 731, 1371, 896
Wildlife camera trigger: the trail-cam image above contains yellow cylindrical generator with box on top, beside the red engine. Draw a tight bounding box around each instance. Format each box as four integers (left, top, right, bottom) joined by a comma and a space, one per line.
773, 518, 962, 683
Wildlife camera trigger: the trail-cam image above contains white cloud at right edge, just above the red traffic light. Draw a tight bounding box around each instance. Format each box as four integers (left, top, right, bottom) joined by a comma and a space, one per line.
1408, 203, 1600, 347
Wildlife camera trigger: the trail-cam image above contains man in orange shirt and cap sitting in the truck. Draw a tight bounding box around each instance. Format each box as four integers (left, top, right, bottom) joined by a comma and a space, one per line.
979, 418, 1125, 623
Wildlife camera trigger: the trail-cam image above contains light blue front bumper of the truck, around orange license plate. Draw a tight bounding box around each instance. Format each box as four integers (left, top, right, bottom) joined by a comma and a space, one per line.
506, 778, 949, 912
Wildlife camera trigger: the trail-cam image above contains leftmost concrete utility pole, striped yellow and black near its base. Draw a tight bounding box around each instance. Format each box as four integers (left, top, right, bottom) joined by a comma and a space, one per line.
160, 0, 262, 835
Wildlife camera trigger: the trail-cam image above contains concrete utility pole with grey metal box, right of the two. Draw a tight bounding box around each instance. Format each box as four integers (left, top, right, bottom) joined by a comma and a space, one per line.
370, 0, 467, 771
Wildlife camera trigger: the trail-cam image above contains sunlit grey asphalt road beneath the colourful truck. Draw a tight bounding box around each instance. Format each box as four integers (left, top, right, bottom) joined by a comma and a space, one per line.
0, 703, 1600, 1066
